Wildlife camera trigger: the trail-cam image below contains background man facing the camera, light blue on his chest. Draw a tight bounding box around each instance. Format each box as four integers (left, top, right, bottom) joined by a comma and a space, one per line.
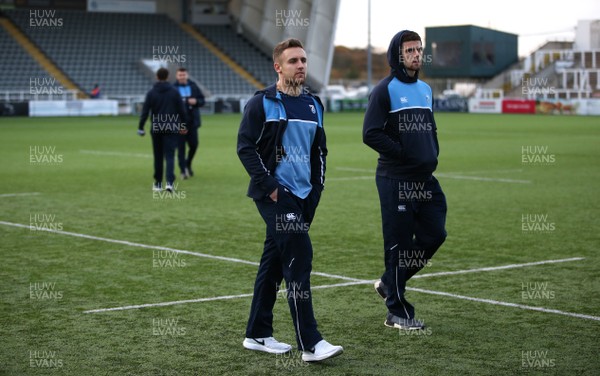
174, 68, 205, 179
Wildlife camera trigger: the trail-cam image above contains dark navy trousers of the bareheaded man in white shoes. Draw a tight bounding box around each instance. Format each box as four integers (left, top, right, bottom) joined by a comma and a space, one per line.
246, 185, 323, 351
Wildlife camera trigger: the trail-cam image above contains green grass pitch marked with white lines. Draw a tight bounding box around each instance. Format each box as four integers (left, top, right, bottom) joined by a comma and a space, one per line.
0, 114, 600, 375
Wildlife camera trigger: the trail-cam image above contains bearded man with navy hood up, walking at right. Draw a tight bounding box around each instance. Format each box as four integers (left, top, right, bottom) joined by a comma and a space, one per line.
363, 30, 446, 330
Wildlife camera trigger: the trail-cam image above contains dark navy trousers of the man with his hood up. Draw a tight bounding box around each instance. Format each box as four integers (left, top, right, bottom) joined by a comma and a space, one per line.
376, 176, 447, 319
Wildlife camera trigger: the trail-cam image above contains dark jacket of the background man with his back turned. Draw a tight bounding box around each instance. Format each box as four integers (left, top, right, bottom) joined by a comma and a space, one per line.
138, 81, 187, 133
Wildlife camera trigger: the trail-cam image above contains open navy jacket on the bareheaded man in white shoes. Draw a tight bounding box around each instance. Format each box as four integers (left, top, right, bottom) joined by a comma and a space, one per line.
237, 85, 327, 200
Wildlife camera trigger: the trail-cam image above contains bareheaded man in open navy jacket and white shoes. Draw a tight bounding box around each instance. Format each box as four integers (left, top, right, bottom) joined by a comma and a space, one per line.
237, 39, 343, 362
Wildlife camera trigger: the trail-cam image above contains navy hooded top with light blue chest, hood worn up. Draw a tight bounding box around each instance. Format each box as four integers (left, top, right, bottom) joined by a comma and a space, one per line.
363, 30, 439, 181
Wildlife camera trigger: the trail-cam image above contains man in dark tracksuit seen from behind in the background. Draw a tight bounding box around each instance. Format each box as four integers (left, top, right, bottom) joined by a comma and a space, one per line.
138, 68, 187, 192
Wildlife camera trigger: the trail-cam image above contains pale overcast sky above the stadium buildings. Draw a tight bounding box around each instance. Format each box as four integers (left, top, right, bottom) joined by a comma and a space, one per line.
335, 0, 600, 56
